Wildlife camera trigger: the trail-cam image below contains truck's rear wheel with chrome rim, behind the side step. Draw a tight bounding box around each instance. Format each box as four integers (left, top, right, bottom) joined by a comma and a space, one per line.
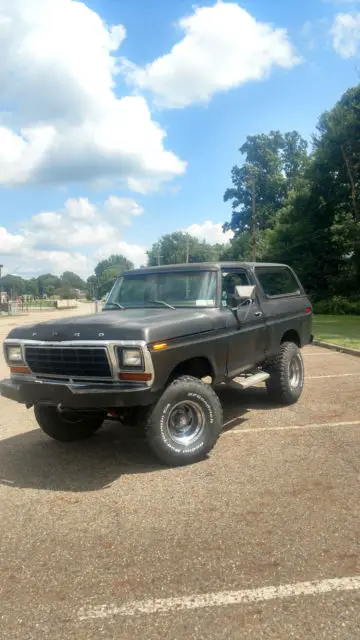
265, 342, 304, 406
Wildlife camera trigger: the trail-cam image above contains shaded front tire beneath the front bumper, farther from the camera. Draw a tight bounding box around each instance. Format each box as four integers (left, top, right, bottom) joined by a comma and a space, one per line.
34, 404, 105, 442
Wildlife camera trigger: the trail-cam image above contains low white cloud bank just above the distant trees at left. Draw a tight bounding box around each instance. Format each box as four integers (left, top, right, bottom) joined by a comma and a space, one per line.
0, 196, 146, 277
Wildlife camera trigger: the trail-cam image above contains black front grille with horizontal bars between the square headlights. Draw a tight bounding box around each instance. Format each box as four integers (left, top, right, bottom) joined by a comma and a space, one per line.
25, 346, 111, 378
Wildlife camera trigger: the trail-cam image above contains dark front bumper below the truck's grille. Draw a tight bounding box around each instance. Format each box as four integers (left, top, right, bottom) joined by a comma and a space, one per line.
0, 378, 156, 409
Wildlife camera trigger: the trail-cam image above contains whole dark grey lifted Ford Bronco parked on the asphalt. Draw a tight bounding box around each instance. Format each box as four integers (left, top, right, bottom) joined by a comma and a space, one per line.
0, 263, 312, 465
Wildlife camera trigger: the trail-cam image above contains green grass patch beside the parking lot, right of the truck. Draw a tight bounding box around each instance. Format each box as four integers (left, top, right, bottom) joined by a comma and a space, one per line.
313, 315, 360, 349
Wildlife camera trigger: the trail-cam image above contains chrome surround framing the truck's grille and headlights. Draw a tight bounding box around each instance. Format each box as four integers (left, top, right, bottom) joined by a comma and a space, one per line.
4, 338, 155, 391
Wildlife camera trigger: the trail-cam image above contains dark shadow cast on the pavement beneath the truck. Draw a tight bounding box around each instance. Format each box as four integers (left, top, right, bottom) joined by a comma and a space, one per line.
0, 386, 274, 492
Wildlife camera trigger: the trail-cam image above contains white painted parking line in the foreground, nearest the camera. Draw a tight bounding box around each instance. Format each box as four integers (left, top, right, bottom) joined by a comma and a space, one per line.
78, 576, 360, 620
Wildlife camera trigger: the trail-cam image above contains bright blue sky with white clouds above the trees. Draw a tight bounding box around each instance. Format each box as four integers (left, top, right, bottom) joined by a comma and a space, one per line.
0, 0, 360, 278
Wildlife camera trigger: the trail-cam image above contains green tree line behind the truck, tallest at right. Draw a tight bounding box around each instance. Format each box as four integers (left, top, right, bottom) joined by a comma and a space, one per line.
2, 85, 360, 314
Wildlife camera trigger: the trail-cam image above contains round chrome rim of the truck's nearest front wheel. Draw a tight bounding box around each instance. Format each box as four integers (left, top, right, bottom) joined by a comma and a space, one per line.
166, 400, 206, 446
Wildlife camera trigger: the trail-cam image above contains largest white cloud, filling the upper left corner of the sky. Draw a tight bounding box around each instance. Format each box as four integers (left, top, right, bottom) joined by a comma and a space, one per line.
0, 0, 185, 191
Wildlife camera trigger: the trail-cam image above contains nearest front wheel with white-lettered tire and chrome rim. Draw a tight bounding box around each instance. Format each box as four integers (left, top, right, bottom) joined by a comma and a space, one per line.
146, 376, 222, 466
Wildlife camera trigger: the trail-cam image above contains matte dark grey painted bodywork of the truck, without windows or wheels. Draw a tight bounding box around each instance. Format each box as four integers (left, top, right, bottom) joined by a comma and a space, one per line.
0, 262, 312, 408
